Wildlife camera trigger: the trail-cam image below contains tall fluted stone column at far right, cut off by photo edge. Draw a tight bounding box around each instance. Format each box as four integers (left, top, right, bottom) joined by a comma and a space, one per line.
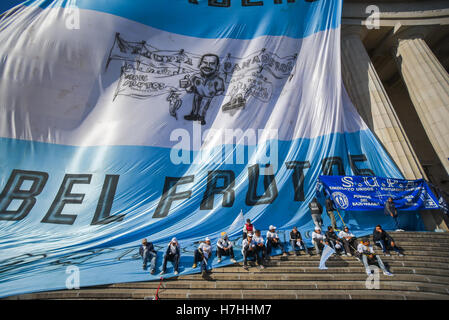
393, 27, 449, 178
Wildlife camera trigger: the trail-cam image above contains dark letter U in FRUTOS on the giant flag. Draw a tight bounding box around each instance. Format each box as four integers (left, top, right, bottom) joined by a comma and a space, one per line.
245, 164, 278, 206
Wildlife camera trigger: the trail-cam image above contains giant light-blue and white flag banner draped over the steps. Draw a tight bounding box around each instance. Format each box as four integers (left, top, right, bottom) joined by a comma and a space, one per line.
0, 0, 422, 297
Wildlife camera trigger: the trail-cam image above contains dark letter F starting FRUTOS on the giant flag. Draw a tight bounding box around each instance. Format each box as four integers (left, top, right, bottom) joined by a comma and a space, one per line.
153, 175, 195, 218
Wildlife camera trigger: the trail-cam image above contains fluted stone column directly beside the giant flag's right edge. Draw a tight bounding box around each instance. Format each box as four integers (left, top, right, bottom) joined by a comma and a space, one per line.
341, 26, 425, 179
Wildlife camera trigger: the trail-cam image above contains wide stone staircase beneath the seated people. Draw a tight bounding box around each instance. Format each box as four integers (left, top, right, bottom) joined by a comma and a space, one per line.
8, 232, 449, 300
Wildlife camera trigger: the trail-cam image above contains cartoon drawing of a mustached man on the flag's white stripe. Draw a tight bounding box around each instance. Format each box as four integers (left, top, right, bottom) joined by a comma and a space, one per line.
180, 54, 225, 125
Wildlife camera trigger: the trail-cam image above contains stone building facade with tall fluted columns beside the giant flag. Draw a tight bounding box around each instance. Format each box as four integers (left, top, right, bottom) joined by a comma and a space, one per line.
341, 0, 449, 231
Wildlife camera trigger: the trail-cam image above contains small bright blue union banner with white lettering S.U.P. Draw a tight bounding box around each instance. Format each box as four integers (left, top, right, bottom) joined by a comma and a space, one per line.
319, 176, 439, 211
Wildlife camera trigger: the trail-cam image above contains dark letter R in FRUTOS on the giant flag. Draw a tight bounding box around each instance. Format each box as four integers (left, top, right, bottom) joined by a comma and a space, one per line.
200, 170, 235, 210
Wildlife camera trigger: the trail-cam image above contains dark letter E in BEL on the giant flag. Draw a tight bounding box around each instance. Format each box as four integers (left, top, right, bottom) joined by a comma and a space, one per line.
41, 174, 92, 225
